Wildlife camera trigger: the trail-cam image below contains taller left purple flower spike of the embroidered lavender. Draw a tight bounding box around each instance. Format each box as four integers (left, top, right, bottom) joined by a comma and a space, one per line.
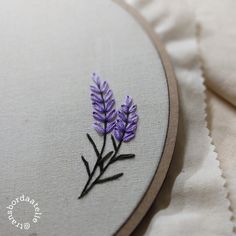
90, 73, 117, 135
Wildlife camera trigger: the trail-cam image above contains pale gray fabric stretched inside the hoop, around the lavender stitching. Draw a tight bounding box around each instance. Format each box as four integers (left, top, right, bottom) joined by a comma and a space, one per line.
0, 0, 168, 236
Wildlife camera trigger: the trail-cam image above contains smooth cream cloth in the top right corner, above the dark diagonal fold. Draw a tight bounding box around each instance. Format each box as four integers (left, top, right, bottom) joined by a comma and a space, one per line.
189, 0, 236, 106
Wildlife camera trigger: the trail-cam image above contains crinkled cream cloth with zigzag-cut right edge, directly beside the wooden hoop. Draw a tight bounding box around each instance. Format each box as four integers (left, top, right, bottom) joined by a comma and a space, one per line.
122, 0, 233, 236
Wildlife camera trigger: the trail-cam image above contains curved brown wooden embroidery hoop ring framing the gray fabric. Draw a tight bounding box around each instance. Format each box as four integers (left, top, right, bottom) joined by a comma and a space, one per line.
113, 0, 179, 236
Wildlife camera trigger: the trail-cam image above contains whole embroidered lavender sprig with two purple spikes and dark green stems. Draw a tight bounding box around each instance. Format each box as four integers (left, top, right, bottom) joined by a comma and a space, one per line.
78, 73, 138, 199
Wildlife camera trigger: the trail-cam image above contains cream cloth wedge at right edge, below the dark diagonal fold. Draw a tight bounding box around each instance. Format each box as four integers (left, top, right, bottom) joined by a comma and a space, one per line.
207, 91, 236, 232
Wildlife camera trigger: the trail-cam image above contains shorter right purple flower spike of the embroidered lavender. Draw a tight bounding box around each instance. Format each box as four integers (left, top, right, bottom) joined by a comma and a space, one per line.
114, 96, 138, 142
